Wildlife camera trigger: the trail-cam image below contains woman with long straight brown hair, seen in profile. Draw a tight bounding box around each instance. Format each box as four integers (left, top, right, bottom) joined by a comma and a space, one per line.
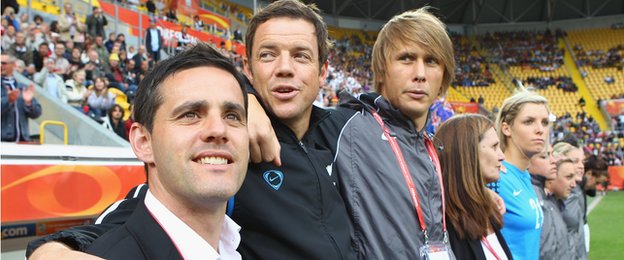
435, 114, 512, 260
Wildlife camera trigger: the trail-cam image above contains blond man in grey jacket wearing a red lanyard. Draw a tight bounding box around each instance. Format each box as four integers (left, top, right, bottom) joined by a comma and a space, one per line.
334, 8, 455, 259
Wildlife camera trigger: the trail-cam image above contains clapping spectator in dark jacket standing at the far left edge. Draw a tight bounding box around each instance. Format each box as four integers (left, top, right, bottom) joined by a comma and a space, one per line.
0, 53, 41, 142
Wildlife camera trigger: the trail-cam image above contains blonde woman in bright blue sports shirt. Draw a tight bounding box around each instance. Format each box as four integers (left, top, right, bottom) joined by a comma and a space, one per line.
496, 90, 550, 259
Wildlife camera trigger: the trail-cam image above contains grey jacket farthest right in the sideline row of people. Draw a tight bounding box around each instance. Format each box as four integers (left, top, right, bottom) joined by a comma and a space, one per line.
562, 186, 587, 260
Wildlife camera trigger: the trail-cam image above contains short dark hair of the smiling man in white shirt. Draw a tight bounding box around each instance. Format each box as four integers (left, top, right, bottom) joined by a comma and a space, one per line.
134, 42, 247, 133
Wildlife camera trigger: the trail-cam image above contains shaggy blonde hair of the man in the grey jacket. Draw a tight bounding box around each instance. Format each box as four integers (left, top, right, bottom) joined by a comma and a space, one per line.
372, 6, 455, 96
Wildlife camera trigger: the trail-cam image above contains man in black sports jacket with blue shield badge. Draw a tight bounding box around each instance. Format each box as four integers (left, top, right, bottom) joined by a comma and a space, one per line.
27, 0, 354, 259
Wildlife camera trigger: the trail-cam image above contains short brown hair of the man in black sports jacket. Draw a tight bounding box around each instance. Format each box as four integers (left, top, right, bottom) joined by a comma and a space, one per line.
245, 0, 331, 67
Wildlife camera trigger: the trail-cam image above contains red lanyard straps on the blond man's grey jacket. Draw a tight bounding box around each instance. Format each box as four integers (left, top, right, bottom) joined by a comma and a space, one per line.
371, 110, 447, 244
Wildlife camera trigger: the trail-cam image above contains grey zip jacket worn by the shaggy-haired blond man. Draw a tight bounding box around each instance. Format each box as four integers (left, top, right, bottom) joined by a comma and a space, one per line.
334, 94, 443, 259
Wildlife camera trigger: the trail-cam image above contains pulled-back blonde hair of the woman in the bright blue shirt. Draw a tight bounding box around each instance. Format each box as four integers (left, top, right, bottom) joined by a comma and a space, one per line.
496, 87, 550, 151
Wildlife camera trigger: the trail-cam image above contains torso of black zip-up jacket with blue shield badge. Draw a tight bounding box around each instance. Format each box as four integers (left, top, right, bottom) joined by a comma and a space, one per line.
232, 107, 354, 259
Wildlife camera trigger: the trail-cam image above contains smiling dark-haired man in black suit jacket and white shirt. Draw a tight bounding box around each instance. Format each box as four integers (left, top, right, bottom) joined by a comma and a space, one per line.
33, 44, 249, 259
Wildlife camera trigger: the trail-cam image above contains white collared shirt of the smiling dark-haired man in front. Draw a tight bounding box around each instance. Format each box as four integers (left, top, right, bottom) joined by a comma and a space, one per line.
145, 190, 241, 260
